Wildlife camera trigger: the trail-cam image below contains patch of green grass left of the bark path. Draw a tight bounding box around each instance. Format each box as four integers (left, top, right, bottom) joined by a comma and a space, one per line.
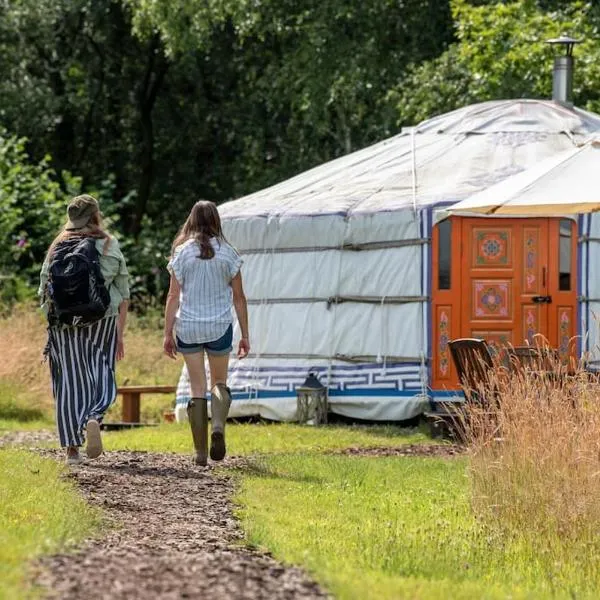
0, 449, 100, 600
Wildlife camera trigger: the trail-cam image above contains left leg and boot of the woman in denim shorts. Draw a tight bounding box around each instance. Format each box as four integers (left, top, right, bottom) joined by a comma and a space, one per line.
183, 351, 208, 466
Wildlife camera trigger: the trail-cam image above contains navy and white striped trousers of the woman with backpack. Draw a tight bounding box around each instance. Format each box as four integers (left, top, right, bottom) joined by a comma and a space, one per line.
49, 317, 117, 447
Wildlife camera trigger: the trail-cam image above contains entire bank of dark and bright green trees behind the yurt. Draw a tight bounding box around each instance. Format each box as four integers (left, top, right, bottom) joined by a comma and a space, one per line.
0, 0, 600, 310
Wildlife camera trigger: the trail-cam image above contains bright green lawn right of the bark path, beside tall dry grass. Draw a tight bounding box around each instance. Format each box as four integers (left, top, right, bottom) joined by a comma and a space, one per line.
237, 455, 600, 600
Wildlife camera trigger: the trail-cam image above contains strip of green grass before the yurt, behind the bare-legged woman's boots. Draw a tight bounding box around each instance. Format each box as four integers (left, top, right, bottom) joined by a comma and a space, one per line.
104, 423, 427, 456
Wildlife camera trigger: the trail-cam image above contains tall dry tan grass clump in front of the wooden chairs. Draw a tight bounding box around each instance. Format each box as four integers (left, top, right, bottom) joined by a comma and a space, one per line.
462, 346, 600, 568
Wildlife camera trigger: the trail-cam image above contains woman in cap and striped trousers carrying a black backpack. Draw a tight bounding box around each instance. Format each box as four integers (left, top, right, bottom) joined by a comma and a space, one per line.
39, 195, 129, 464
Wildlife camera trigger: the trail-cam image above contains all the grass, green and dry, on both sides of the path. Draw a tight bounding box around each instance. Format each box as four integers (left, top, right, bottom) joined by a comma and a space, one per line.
0, 310, 600, 599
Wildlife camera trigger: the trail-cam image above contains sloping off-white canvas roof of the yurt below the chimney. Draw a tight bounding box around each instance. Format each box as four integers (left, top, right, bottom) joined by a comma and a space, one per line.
220, 100, 600, 220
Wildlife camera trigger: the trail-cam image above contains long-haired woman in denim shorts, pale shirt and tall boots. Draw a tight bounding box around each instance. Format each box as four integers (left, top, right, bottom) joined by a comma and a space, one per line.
164, 201, 250, 466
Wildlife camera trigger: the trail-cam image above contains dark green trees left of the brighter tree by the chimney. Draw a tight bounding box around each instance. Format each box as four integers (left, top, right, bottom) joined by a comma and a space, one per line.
0, 0, 452, 305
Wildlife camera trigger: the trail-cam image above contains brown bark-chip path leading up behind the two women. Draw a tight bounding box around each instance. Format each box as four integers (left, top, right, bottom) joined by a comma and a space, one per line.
35, 451, 327, 600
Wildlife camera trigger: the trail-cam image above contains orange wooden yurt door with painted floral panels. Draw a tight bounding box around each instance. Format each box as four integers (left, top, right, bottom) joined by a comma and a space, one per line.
432, 217, 577, 389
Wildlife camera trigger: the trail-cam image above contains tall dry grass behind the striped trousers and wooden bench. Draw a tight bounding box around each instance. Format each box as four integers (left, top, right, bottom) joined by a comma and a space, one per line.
0, 306, 182, 420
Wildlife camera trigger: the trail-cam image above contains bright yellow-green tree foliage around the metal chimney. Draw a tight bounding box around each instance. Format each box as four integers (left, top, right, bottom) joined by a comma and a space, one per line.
389, 0, 600, 123
